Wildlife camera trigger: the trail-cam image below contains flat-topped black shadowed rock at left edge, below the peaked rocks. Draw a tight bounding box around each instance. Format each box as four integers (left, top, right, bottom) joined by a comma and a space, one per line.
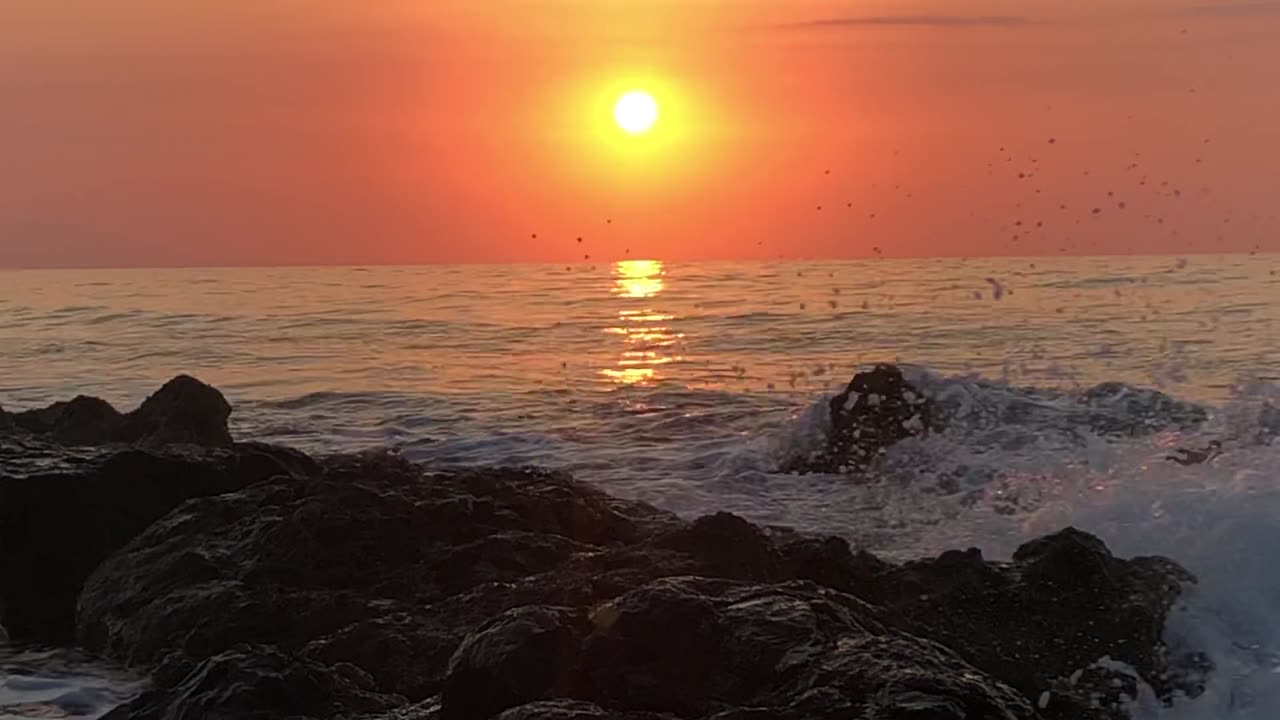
0, 438, 315, 642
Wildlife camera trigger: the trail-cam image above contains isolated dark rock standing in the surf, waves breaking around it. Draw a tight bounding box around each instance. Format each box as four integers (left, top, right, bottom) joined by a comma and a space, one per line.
785, 365, 932, 473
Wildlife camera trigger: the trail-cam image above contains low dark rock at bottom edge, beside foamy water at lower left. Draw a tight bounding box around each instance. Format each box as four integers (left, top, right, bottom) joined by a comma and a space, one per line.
104, 646, 404, 720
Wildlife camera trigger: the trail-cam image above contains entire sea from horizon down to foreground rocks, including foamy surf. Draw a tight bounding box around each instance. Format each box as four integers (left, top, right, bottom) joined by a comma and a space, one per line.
0, 256, 1280, 719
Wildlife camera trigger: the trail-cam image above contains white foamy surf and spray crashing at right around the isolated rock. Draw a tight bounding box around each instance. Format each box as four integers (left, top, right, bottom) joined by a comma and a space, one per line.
744, 369, 1280, 720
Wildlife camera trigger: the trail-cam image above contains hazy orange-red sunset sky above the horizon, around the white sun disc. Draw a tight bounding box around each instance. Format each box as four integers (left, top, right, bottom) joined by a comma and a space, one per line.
0, 0, 1280, 266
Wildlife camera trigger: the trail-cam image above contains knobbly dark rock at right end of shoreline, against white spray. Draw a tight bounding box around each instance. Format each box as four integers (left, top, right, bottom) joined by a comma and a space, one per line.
867, 528, 1194, 719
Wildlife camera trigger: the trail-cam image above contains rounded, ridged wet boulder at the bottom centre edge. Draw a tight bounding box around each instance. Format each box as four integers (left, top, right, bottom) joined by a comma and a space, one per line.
442, 578, 1036, 720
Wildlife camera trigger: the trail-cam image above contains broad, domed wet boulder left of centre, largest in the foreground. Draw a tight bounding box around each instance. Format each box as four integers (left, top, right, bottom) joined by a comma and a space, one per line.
79, 455, 676, 671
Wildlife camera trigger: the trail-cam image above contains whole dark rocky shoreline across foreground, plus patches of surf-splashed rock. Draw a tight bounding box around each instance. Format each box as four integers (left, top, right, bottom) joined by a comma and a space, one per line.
0, 369, 1211, 720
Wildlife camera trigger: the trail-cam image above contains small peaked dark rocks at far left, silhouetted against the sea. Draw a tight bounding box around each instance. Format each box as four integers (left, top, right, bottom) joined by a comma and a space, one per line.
13, 375, 232, 447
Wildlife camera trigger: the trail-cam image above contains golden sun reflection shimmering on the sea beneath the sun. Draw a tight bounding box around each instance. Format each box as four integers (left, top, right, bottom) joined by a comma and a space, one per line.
600, 260, 685, 384
